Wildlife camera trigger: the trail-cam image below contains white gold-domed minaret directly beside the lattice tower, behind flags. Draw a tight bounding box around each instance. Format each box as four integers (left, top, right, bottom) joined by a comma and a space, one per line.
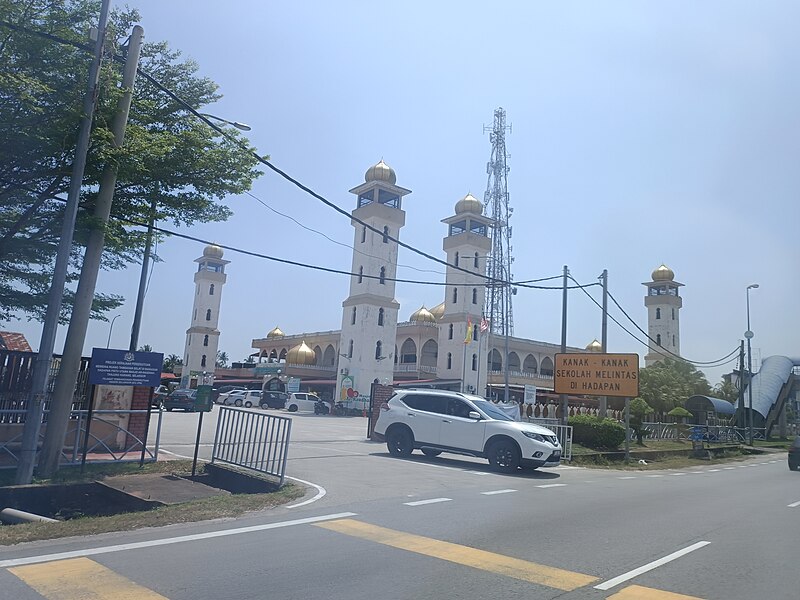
440, 194, 492, 395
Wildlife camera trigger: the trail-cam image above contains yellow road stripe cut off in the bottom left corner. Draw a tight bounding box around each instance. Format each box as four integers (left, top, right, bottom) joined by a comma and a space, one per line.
9, 558, 169, 600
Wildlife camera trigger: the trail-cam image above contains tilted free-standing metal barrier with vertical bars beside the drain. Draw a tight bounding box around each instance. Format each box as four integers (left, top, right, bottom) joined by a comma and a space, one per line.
211, 406, 292, 485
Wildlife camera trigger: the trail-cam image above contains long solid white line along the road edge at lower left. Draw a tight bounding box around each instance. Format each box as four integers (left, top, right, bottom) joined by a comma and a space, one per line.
0, 512, 357, 569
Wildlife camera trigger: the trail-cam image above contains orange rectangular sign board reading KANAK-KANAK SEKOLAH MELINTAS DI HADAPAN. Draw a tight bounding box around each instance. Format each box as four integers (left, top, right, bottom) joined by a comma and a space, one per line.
554, 353, 639, 398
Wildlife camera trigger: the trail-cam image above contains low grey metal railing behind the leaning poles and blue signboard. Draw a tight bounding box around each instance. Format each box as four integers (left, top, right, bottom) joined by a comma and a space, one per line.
0, 410, 163, 469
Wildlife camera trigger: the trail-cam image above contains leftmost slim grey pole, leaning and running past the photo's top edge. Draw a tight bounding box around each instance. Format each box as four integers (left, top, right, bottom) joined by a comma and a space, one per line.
16, 0, 111, 484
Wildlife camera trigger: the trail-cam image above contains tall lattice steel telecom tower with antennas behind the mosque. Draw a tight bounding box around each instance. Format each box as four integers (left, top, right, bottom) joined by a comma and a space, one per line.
483, 108, 515, 336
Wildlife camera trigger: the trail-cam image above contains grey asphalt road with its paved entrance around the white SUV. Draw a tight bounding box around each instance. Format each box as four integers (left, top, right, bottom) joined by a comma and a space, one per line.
0, 413, 800, 600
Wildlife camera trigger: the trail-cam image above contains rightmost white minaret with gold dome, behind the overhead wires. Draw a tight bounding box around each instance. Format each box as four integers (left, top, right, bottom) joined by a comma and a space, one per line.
642, 265, 683, 367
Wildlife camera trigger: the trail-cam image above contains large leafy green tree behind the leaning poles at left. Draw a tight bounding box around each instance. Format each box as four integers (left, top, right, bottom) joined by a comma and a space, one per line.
0, 0, 259, 321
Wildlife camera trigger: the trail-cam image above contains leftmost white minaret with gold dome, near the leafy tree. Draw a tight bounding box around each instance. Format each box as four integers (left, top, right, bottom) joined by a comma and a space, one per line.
181, 245, 230, 388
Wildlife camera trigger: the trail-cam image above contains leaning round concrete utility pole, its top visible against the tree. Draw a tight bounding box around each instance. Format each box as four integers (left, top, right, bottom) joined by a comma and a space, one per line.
39, 25, 144, 477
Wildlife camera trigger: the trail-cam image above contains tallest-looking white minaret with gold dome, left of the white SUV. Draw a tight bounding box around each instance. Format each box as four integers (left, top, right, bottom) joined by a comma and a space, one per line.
336, 159, 411, 400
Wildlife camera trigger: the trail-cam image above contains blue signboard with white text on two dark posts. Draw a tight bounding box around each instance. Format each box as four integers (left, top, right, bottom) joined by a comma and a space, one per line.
86, 348, 164, 473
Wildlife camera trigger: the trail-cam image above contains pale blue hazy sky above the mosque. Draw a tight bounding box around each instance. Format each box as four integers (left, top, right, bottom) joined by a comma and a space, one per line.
5, 0, 800, 385
